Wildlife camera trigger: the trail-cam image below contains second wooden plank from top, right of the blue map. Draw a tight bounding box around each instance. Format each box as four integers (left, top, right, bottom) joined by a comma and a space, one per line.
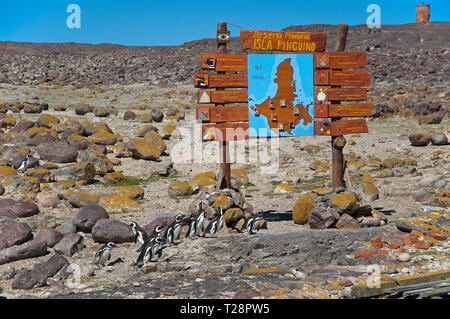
314, 70, 370, 86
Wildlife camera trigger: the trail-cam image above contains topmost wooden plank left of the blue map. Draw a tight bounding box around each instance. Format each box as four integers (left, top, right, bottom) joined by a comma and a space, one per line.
200, 52, 247, 72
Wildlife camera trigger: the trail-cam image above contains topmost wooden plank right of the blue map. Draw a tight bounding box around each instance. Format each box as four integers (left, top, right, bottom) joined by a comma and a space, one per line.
315, 51, 367, 69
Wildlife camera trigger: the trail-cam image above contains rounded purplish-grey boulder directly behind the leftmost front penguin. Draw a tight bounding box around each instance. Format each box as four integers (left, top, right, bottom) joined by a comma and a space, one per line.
92, 218, 134, 243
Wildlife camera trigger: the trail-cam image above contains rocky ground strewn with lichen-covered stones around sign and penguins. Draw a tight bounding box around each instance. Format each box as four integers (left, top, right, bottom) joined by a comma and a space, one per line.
0, 23, 450, 298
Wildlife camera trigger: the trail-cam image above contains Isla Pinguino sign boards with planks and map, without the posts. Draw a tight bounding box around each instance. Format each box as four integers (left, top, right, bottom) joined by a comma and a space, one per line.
194, 30, 372, 141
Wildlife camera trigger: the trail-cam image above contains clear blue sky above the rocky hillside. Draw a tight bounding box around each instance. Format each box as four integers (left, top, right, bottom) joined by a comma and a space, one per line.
0, 0, 450, 45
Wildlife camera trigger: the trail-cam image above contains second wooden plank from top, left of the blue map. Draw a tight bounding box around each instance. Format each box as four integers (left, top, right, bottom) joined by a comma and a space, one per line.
194, 72, 248, 88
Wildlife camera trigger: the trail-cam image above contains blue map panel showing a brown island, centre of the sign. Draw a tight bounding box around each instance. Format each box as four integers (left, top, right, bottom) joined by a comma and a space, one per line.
248, 54, 314, 137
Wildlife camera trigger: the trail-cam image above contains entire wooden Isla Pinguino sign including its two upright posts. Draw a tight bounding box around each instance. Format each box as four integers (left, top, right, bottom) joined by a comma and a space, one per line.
194, 23, 372, 192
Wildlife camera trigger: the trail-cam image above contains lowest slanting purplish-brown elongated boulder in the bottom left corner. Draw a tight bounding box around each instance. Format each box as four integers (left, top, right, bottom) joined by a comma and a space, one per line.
11, 255, 69, 290
